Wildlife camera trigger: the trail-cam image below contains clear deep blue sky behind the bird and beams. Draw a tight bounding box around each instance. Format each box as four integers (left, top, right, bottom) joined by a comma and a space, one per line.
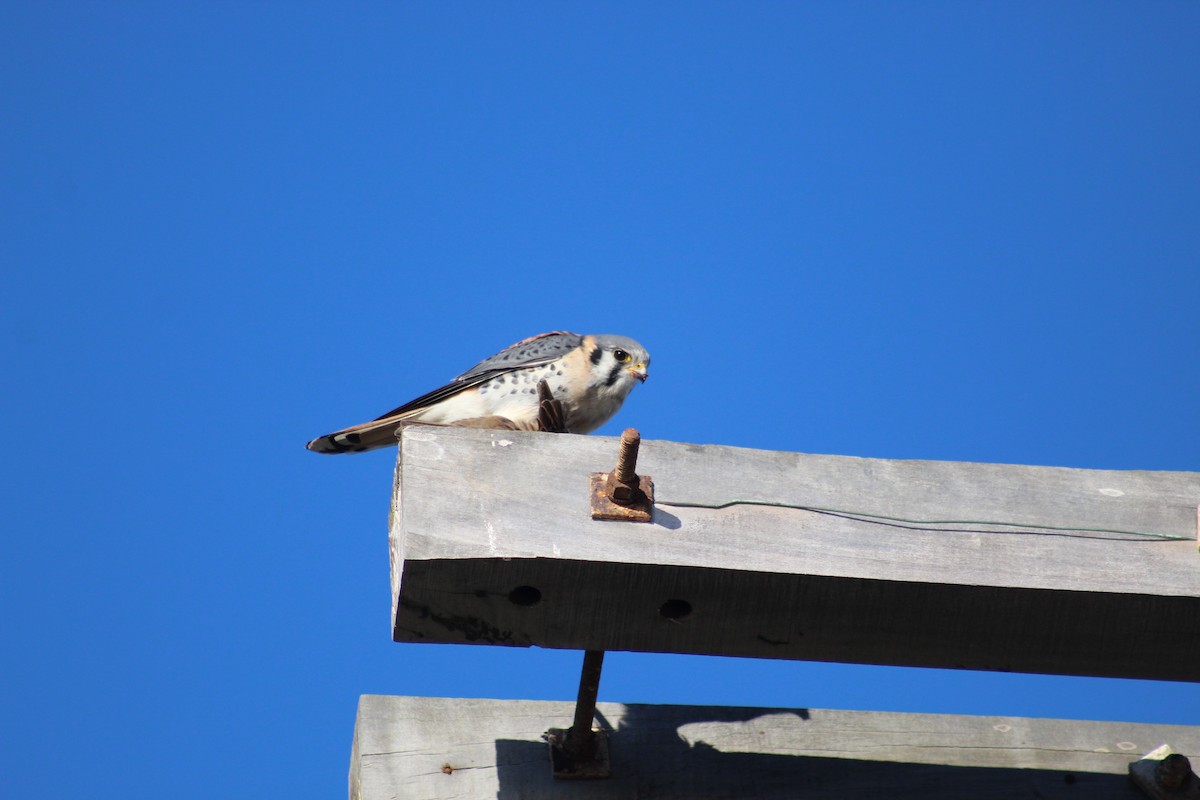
0, 1, 1200, 798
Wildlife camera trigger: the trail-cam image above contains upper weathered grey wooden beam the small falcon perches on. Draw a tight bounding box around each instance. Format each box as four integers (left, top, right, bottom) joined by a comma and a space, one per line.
391, 426, 1200, 680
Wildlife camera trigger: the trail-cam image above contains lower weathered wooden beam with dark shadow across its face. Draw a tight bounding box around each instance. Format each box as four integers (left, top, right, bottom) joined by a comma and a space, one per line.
349, 694, 1200, 800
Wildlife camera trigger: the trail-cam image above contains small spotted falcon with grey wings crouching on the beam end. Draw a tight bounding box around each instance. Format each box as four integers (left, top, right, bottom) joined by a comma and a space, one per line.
307, 331, 650, 453
